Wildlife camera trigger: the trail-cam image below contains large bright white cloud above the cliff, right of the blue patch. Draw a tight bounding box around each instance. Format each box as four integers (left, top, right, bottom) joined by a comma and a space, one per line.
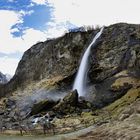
48, 0, 140, 26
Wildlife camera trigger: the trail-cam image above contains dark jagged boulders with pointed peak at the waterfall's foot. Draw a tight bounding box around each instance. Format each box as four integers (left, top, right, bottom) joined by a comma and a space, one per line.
28, 90, 92, 116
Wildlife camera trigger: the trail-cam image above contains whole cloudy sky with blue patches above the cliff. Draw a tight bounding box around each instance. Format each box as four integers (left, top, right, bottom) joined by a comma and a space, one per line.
0, 0, 140, 75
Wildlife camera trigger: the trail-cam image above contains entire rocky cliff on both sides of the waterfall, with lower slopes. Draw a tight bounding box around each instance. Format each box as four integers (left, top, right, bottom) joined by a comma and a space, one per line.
0, 23, 140, 133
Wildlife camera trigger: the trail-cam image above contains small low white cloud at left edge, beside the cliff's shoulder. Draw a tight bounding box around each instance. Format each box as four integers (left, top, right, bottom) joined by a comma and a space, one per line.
0, 57, 19, 75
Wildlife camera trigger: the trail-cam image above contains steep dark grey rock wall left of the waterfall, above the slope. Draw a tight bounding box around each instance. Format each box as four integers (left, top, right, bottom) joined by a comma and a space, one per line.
7, 31, 93, 91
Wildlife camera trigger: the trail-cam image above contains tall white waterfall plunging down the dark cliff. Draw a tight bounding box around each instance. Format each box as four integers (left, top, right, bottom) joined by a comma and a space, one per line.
73, 27, 104, 96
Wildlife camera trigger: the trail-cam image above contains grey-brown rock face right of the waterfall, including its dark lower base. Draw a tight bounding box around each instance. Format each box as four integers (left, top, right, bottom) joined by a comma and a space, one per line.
88, 23, 140, 107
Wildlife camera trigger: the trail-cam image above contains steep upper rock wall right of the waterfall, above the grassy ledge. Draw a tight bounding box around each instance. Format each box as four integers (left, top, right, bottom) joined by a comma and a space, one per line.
89, 23, 140, 81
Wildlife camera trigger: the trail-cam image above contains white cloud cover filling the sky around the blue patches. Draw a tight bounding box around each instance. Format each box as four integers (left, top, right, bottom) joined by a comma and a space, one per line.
0, 0, 140, 74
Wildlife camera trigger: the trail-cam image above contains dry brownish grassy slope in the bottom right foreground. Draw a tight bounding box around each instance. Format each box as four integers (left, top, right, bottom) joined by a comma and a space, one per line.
71, 97, 140, 140
